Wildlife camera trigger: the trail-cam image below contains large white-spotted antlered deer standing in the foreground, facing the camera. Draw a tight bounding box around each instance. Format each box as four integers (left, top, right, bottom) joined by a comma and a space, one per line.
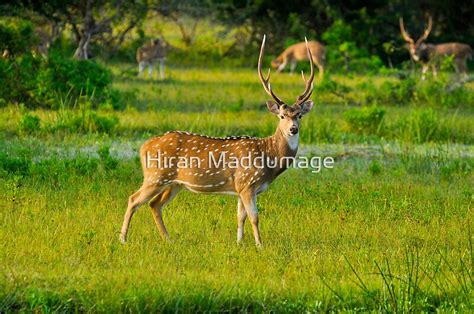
120, 35, 314, 247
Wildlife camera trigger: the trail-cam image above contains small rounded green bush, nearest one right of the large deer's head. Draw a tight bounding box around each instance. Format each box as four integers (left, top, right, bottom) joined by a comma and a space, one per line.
344, 106, 385, 134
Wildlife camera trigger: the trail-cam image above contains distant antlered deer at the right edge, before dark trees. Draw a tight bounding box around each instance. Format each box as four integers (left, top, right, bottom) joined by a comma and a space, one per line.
400, 16, 472, 80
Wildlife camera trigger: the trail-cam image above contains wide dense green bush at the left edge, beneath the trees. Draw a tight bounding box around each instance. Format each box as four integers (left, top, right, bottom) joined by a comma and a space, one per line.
0, 54, 118, 109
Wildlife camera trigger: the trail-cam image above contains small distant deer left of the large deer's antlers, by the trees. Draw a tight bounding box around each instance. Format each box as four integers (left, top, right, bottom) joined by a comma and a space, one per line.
137, 39, 167, 79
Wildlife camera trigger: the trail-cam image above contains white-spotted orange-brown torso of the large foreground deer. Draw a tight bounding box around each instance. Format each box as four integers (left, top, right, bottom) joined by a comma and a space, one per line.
140, 131, 296, 194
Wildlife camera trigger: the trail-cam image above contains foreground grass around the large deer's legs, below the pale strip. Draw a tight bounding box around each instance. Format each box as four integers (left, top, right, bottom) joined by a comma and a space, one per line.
0, 140, 473, 312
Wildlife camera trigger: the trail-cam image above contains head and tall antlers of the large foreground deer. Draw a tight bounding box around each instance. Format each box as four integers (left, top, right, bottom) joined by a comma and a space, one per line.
258, 35, 314, 137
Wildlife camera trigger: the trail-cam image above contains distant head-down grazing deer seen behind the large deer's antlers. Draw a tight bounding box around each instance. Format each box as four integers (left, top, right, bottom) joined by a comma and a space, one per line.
272, 41, 326, 77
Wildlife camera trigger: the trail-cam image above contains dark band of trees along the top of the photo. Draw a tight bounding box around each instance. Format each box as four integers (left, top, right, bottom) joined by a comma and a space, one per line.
2, 0, 474, 65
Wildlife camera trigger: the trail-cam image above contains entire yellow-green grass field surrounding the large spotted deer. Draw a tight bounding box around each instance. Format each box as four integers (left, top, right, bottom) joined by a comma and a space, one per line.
0, 65, 474, 312
